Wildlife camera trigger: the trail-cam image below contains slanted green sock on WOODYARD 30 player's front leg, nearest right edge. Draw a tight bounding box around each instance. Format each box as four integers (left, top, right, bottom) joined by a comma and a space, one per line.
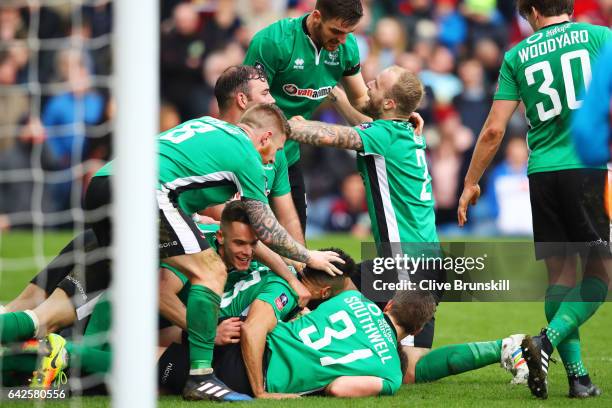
546, 277, 608, 348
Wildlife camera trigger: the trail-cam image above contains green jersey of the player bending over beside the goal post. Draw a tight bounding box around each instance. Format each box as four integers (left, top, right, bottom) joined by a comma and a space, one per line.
96, 116, 268, 214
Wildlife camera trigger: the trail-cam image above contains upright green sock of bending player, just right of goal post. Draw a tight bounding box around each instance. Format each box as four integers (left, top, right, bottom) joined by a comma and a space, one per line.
187, 285, 221, 370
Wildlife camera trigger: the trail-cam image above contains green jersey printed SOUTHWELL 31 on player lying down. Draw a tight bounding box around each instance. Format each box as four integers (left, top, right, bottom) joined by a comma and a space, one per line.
266, 291, 402, 395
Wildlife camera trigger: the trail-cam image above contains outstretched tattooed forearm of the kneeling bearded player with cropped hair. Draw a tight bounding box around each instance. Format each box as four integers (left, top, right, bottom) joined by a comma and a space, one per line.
289, 121, 363, 151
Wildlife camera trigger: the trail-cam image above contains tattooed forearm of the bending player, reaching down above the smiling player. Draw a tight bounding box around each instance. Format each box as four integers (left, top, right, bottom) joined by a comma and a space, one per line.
243, 199, 310, 263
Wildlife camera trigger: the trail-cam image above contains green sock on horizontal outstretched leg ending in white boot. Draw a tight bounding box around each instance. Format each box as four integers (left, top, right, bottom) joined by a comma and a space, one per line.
415, 340, 502, 383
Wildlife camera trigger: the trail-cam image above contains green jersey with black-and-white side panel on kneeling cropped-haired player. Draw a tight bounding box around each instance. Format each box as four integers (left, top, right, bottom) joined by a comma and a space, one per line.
355, 120, 438, 247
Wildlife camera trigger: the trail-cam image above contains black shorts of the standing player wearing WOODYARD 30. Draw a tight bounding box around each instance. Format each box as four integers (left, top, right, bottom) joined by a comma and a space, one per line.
529, 169, 610, 259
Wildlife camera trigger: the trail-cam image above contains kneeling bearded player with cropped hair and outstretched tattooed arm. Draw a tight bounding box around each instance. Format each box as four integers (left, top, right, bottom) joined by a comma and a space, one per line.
289, 67, 438, 383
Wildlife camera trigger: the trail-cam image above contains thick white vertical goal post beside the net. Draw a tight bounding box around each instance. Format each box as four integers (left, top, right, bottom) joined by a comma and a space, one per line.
110, 0, 159, 408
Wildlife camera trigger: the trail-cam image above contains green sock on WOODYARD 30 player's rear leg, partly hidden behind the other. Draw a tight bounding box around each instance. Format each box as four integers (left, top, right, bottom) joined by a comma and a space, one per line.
544, 285, 588, 376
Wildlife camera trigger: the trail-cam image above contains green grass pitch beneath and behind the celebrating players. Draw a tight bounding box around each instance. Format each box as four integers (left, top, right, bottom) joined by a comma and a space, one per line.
0, 232, 612, 408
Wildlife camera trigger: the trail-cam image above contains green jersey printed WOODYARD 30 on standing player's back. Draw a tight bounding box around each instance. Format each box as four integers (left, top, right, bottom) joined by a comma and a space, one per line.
495, 23, 612, 174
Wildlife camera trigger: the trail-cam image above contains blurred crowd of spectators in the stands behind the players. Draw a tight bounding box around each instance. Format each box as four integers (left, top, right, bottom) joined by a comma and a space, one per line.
0, 0, 612, 238
